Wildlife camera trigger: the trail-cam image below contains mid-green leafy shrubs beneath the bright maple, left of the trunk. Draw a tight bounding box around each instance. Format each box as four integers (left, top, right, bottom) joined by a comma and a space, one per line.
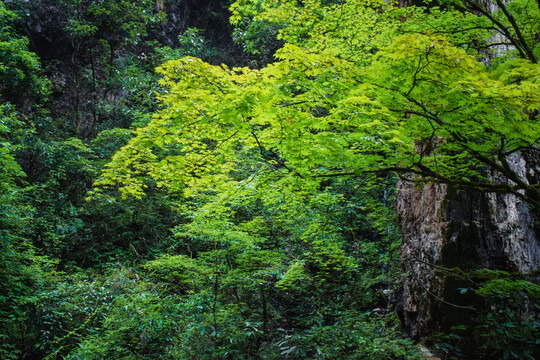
67, 170, 417, 359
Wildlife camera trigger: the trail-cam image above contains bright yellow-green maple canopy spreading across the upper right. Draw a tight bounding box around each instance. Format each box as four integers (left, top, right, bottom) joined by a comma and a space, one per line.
97, 1, 540, 206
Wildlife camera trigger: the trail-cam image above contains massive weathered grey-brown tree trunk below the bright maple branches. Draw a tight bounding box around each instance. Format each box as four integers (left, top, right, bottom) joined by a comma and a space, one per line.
397, 151, 540, 340
